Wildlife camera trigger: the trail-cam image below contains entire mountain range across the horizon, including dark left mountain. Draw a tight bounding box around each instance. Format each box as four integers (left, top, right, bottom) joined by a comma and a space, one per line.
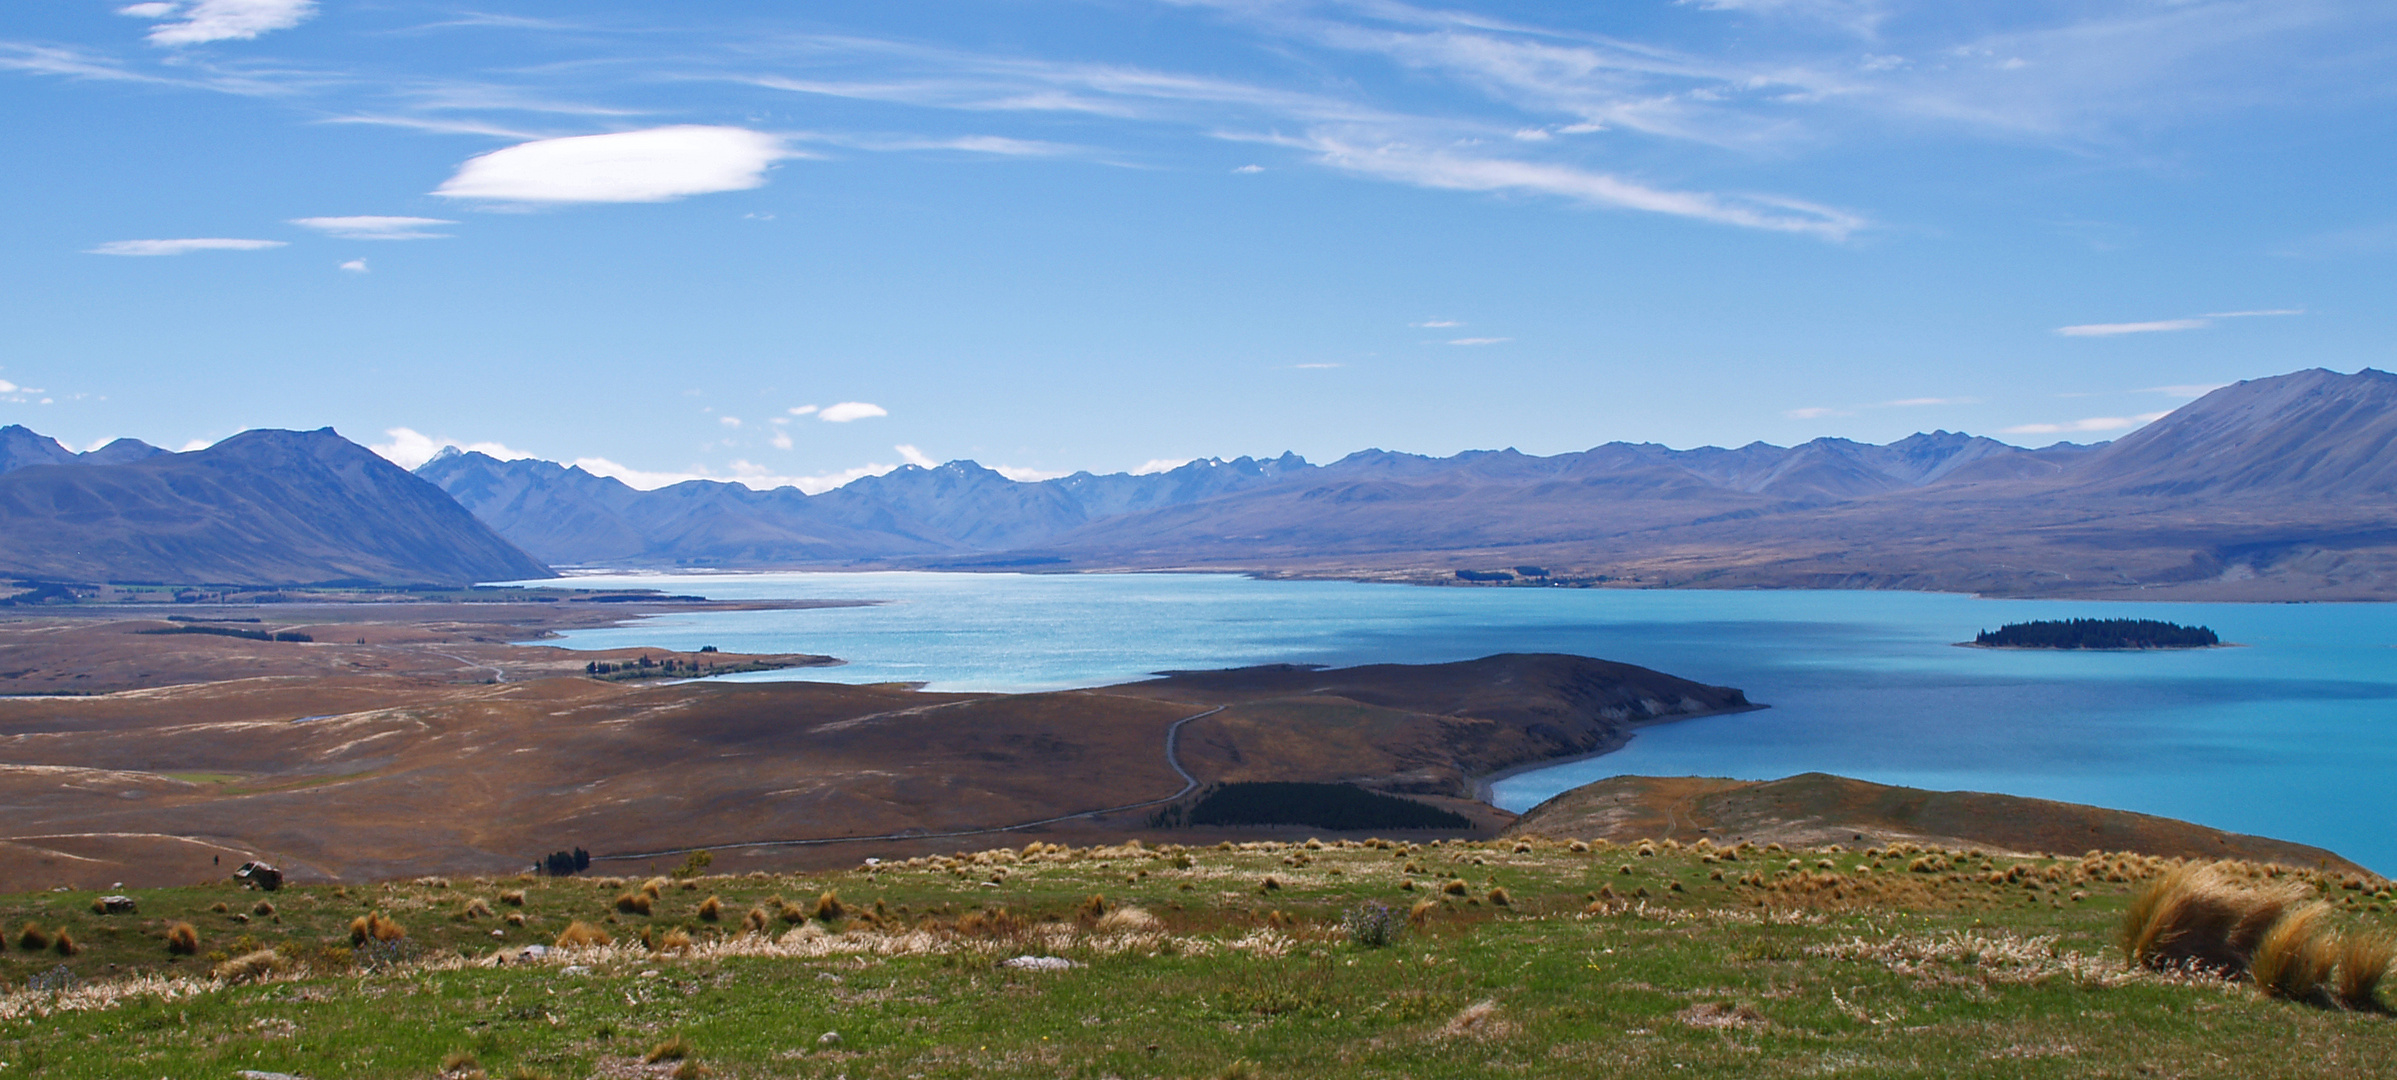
0, 369, 2397, 599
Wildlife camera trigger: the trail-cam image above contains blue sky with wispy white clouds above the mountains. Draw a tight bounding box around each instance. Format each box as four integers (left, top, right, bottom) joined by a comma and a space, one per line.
0, 0, 2397, 489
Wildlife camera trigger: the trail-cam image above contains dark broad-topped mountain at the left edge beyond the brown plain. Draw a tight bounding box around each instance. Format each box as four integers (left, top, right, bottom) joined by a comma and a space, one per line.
0, 429, 551, 584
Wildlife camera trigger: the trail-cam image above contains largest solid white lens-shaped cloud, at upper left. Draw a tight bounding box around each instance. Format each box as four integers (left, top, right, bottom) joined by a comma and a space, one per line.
434, 125, 789, 204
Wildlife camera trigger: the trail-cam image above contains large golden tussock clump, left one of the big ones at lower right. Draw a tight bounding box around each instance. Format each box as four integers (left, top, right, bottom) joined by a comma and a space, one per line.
2119, 862, 2304, 979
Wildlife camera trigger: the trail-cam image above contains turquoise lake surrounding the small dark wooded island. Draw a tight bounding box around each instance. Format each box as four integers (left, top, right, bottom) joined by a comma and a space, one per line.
505, 572, 2397, 874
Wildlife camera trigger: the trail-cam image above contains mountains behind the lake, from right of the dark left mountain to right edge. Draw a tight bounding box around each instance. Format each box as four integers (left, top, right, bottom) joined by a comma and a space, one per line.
402, 369, 2397, 599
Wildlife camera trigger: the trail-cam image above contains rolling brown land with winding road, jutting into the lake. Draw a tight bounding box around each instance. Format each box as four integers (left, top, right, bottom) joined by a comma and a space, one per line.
0, 654, 1747, 891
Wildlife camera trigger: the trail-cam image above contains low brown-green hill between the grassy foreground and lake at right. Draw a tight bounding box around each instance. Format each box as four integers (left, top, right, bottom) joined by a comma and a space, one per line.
1508, 773, 2366, 874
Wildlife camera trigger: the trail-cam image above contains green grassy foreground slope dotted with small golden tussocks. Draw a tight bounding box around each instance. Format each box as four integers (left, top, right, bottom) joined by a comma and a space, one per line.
0, 841, 2397, 1080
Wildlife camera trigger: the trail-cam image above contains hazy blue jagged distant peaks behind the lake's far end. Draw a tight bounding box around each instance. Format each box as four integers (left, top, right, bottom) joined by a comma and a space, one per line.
417, 431, 2090, 565
